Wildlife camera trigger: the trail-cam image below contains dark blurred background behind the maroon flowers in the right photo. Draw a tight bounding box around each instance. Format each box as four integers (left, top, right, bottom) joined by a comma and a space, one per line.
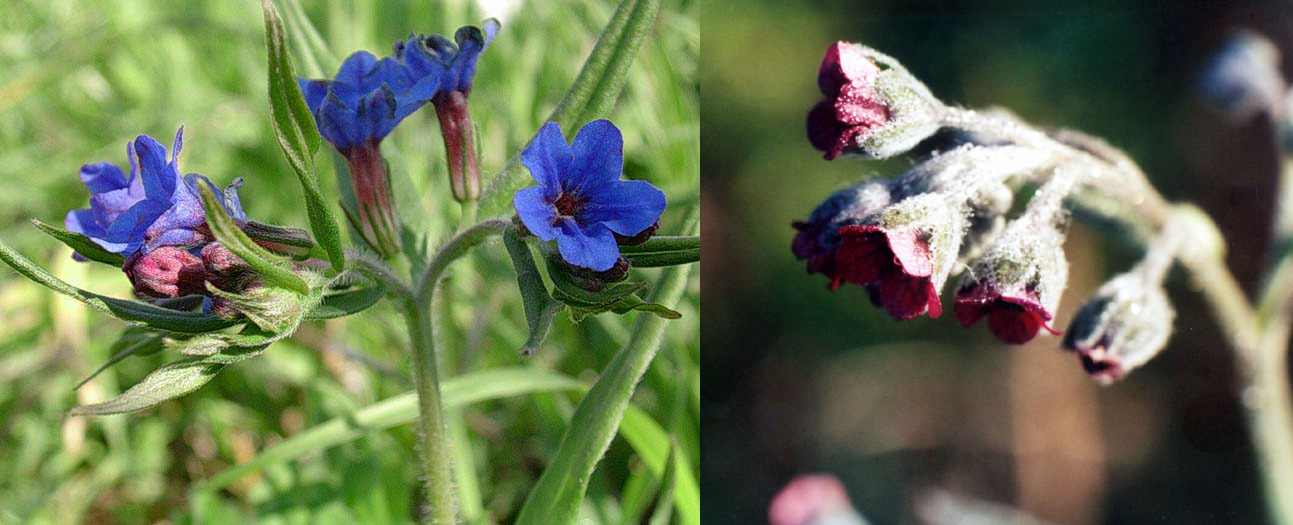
701, 0, 1293, 524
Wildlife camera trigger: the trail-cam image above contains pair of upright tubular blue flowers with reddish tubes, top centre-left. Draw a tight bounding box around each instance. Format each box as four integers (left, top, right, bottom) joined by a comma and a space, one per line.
297, 19, 498, 257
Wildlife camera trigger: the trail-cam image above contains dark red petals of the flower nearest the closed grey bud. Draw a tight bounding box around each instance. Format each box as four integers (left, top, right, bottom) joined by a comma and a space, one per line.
953, 281, 1060, 344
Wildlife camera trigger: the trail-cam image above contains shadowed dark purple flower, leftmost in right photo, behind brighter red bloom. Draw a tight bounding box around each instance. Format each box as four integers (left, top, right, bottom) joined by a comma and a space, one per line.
790, 181, 892, 290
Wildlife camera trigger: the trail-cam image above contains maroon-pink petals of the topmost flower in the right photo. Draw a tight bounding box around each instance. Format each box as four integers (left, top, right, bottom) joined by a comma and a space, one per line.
808, 41, 890, 160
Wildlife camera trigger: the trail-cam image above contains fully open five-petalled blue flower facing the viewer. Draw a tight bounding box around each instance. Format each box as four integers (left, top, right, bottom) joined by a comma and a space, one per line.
512, 120, 665, 272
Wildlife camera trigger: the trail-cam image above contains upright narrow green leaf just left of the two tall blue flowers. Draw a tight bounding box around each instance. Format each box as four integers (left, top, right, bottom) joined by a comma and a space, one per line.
261, 0, 345, 272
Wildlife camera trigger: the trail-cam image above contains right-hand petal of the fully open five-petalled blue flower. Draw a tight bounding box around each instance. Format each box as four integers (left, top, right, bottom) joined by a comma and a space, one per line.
575, 181, 665, 235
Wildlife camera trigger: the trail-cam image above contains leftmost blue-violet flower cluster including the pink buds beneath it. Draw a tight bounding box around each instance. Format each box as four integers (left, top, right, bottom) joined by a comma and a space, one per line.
63, 128, 267, 311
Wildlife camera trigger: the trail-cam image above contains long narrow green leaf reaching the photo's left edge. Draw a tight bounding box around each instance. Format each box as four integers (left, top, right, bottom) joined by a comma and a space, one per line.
0, 237, 237, 334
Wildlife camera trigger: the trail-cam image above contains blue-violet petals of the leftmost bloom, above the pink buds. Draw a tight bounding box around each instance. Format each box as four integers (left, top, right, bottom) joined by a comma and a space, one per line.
63, 128, 247, 259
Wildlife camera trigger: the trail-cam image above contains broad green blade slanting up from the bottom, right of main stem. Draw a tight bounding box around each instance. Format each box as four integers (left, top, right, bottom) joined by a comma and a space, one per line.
516, 248, 690, 525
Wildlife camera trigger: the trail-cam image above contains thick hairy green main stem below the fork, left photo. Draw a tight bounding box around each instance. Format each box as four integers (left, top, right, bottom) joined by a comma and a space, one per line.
403, 300, 458, 525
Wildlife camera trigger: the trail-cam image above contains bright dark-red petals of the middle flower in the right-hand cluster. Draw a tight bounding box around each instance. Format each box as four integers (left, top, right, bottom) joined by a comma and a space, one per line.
834, 225, 943, 319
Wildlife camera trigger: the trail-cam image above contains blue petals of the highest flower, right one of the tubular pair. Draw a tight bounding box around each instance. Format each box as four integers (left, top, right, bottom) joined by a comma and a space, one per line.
396, 18, 499, 93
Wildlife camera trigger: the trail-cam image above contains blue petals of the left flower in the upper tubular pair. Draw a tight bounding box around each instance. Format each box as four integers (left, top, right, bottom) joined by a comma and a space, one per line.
296, 50, 442, 153
